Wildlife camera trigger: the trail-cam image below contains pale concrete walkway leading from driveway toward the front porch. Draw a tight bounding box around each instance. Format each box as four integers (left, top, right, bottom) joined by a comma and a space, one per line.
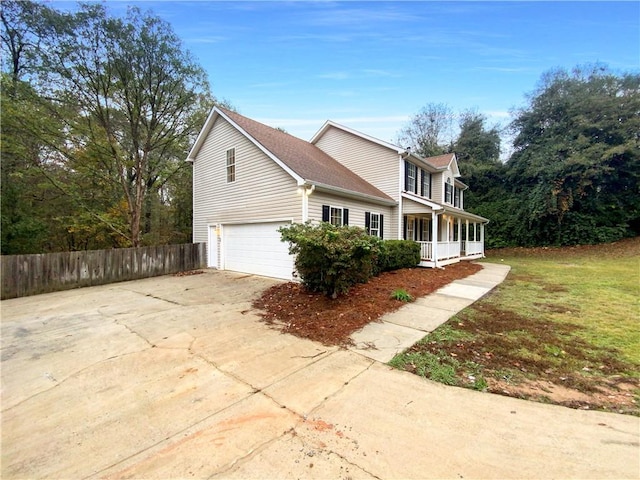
350, 263, 511, 363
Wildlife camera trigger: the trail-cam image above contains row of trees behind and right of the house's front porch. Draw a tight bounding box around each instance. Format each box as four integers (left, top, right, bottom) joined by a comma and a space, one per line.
398, 64, 640, 248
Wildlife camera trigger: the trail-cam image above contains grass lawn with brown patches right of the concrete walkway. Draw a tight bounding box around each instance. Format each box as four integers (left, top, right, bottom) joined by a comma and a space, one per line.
390, 237, 640, 414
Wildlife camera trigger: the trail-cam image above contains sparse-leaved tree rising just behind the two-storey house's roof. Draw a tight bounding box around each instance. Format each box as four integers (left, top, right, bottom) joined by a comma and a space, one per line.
398, 103, 453, 157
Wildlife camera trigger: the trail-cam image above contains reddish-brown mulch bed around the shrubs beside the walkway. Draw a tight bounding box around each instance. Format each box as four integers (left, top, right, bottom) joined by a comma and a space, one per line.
253, 262, 482, 346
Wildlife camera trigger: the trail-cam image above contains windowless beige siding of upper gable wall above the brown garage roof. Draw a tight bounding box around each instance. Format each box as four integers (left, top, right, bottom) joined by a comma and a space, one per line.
316, 127, 400, 201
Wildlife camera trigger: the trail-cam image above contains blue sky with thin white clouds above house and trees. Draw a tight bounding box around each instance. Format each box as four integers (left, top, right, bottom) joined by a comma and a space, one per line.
57, 0, 640, 145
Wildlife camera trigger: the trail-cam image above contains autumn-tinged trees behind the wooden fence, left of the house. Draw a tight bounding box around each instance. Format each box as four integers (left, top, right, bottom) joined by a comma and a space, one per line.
1, 1, 225, 254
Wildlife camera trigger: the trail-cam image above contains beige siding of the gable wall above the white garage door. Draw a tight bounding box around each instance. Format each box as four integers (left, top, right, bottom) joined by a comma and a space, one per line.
193, 117, 302, 242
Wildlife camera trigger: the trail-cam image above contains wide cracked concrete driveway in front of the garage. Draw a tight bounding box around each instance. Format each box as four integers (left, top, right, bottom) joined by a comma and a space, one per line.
1, 271, 640, 479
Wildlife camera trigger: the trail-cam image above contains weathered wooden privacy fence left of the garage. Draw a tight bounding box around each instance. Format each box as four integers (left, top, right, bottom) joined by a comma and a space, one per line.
1, 243, 206, 300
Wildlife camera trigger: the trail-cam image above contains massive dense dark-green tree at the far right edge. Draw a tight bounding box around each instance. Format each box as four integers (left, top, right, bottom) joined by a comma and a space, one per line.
507, 65, 640, 245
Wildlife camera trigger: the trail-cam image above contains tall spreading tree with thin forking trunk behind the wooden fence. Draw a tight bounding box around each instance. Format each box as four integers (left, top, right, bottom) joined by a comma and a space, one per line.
38, 5, 212, 246
